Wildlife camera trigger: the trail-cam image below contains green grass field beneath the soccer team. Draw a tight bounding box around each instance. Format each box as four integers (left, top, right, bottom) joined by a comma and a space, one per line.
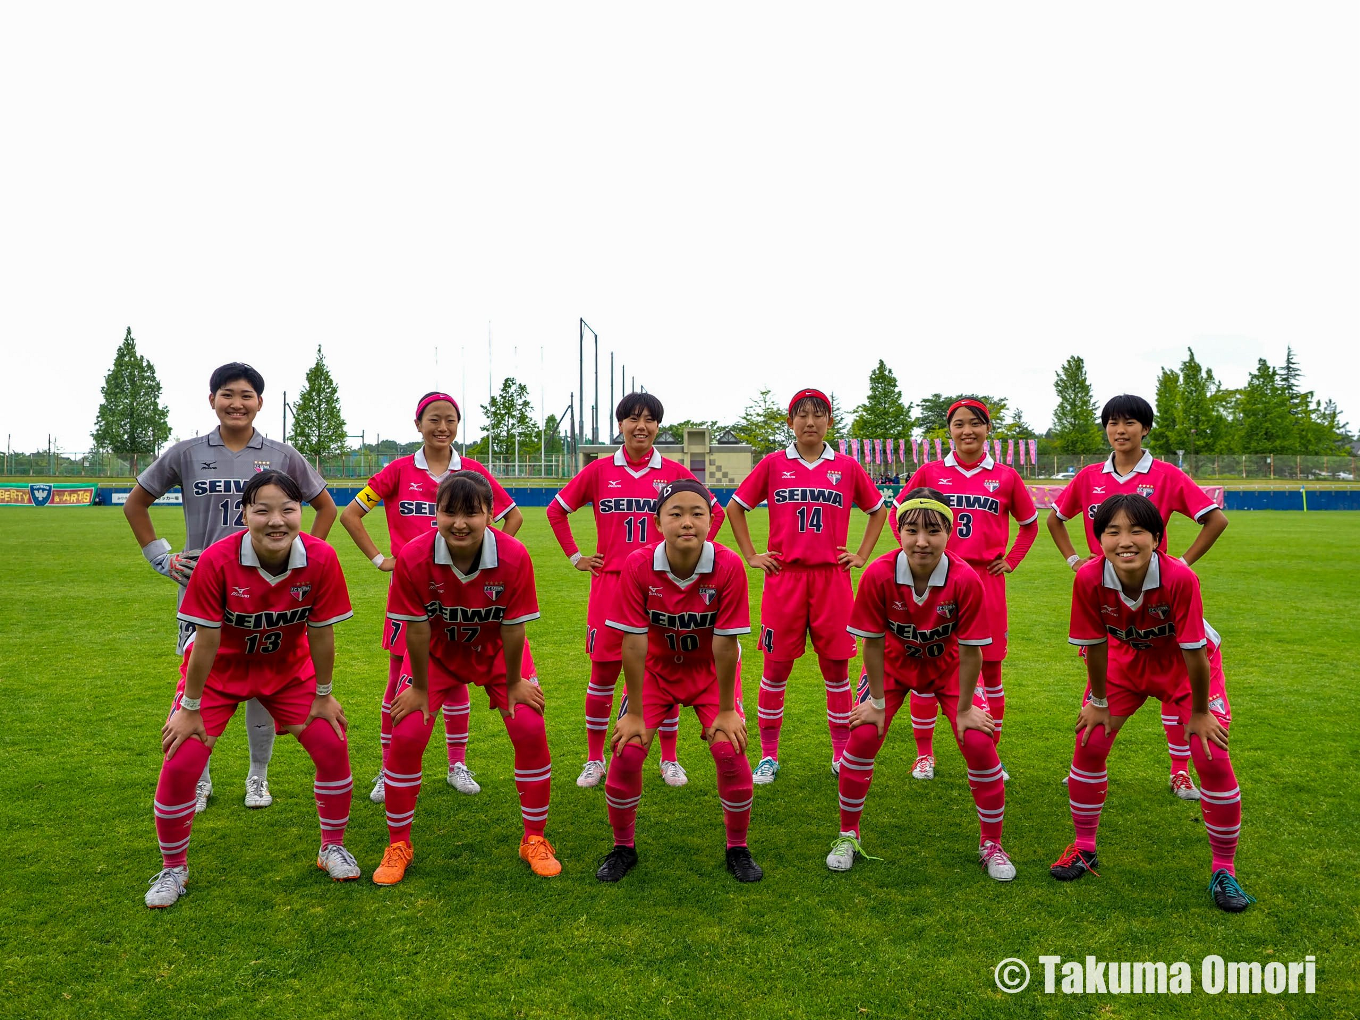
0, 509, 1360, 1020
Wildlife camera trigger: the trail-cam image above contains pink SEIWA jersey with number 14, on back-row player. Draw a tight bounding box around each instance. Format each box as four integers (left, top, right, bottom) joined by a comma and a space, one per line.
732, 443, 884, 567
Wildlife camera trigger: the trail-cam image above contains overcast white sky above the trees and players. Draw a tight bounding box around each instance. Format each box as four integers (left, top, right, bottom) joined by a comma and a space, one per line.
0, 0, 1360, 450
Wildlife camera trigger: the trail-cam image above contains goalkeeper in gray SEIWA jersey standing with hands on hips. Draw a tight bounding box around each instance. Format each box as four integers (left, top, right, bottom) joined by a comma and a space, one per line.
122, 362, 336, 812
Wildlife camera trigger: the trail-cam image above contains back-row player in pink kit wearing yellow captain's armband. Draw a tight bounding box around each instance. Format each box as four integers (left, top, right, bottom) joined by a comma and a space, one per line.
340, 390, 536, 804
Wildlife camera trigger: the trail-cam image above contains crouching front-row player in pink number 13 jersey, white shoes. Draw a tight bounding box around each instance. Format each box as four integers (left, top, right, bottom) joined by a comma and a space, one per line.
146, 471, 359, 907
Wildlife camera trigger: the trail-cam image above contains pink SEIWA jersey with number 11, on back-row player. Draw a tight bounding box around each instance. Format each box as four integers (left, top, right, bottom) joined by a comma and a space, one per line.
556, 449, 722, 574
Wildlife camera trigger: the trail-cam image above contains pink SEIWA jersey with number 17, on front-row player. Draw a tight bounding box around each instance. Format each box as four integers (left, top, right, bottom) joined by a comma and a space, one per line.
388, 528, 539, 683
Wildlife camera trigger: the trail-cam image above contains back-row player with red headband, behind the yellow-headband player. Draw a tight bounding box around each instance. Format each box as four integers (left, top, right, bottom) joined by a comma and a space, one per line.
886, 397, 1039, 779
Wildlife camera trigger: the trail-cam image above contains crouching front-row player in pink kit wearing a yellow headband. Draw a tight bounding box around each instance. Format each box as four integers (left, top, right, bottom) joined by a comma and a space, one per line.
827, 488, 1016, 881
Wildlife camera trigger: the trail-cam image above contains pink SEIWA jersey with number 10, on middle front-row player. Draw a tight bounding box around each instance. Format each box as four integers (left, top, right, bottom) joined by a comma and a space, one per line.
608, 541, 751, 684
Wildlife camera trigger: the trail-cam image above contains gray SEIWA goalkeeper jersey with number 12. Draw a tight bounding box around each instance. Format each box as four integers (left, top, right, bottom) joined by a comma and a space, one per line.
137, 428, 326, 651
